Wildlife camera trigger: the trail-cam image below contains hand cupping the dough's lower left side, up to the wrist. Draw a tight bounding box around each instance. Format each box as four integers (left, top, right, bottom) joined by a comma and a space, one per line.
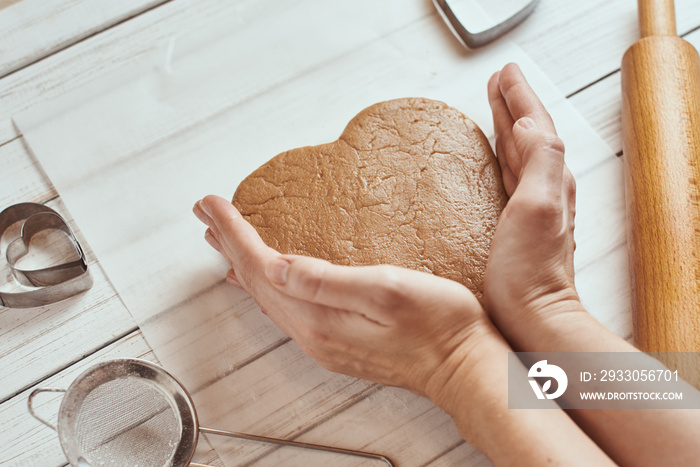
194, 196, 494, 404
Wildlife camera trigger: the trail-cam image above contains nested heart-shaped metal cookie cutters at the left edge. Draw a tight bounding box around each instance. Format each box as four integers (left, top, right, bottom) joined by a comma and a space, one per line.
0, 203, 92, 308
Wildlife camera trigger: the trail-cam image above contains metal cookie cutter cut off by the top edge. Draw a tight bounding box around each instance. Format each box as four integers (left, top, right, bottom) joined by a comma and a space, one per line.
433, 0, 540, 49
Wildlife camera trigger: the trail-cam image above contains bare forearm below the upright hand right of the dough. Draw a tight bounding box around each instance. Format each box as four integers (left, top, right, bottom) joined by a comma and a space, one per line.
508, 301, 700, 466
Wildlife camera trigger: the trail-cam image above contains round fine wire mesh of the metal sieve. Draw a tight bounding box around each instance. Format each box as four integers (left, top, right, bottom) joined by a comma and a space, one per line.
75, 377, 182, 467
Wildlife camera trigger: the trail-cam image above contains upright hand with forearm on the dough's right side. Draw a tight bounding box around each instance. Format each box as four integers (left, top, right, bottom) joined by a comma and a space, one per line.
484, 64, 700, 465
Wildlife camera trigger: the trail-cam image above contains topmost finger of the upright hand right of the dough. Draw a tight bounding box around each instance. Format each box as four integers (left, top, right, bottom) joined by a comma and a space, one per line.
498, 63, 556, 134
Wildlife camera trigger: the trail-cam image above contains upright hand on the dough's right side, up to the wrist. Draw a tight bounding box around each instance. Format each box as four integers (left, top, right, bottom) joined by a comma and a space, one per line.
484, 64, 585, 350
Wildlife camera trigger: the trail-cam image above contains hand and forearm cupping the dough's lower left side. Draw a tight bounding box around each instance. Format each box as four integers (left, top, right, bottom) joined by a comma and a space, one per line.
194, 196, 608, 465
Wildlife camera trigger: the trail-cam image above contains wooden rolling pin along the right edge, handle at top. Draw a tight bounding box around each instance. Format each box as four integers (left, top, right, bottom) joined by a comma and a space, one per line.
622, 0, 700, 352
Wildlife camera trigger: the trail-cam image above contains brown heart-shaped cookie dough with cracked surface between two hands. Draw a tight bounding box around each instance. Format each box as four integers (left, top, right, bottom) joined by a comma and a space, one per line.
233, 99, 507, 301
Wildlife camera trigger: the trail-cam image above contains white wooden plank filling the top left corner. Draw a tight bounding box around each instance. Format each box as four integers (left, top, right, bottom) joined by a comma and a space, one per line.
0, 0, 167, 77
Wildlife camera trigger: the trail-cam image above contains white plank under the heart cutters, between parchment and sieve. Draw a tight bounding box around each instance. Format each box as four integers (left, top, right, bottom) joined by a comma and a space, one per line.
0, 198, 136, 401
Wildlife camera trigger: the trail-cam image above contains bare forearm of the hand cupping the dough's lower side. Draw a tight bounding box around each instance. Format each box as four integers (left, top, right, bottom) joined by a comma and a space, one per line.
424, 326, 611, 466
